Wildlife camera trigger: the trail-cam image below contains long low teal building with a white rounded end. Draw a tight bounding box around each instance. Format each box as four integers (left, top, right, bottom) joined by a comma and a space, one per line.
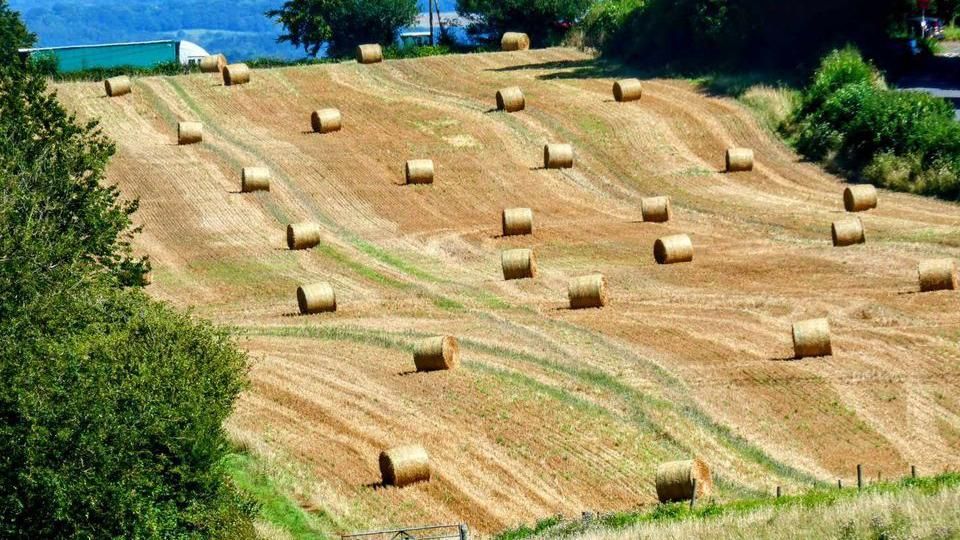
20, 40, 208, 73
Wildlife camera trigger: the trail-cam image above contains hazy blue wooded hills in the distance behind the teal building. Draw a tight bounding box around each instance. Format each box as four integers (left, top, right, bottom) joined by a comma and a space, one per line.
10, 0, 456, 60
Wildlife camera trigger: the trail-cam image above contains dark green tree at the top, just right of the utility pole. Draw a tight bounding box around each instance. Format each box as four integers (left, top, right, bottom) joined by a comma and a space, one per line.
457, 0, 593, 46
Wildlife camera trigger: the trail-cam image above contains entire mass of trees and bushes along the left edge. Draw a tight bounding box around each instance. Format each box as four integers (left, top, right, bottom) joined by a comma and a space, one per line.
0, 4, 254, 538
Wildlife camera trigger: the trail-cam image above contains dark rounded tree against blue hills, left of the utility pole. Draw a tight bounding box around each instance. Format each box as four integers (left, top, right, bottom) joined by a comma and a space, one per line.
267, 0, 418, 56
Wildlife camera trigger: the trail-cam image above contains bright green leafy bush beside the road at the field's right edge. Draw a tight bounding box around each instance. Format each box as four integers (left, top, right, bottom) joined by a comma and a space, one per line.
786, 49, 960, 199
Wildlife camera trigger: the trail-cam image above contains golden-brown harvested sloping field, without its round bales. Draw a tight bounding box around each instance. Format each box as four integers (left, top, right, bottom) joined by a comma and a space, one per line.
58, 49, 960, 531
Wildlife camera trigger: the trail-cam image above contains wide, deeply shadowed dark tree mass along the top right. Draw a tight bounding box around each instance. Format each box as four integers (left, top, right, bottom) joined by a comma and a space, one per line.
585, 0, 904, 69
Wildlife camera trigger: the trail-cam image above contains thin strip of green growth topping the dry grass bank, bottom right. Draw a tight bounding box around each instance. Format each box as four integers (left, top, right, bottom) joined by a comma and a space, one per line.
494, 473, 960, 540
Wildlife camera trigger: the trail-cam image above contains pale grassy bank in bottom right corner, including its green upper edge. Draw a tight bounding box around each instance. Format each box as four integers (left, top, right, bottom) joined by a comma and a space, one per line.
497, 473, 960, 540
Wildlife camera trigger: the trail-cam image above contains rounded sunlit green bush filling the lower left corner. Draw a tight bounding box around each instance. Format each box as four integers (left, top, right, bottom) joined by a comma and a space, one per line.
0, 284, 253, 538
